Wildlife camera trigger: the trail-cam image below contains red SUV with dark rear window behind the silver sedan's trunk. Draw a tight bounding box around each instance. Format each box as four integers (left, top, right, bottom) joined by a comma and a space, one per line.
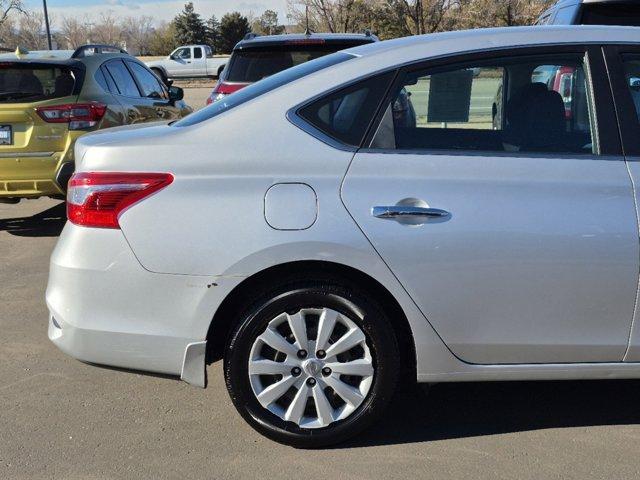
207, 33, 378, 104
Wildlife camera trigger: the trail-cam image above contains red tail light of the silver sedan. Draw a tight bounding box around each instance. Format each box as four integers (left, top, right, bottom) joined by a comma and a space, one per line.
67, 172, 173, 228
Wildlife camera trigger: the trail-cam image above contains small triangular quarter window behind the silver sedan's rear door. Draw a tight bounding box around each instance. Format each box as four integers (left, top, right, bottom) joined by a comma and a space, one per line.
298, 72, 395, 147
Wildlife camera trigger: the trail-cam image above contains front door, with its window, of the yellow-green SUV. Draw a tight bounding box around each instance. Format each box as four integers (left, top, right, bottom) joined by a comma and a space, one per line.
125, 60, 180, 121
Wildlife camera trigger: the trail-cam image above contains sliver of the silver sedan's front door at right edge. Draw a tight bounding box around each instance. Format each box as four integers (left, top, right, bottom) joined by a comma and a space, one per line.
605, 45, 640, 362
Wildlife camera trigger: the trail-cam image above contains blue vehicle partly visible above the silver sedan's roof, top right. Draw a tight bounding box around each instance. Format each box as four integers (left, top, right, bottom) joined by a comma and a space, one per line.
536, 0, 640, 27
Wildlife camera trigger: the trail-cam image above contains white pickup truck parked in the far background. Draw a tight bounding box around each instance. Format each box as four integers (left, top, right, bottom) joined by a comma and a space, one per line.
145, 45, 229, 81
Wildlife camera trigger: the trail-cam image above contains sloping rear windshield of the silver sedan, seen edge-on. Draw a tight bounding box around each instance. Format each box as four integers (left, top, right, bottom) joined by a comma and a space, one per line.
172, 53, 355, 127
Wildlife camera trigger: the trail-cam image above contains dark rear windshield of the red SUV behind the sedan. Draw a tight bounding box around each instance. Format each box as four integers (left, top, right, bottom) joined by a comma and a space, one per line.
225, 42, 362, 83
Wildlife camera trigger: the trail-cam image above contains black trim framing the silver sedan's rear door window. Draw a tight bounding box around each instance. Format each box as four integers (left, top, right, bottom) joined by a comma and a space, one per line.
362, 44, 622, 158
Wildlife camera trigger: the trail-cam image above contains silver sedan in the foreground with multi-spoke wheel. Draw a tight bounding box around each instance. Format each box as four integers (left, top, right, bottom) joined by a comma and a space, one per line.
47, 27, 640, 447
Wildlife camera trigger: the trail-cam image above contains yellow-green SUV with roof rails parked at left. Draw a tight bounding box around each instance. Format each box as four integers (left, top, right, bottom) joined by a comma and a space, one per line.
0, 45, 193, 203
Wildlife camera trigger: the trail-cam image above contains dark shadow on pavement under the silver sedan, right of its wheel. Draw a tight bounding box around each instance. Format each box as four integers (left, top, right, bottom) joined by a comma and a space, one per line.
338, 380, 640, 448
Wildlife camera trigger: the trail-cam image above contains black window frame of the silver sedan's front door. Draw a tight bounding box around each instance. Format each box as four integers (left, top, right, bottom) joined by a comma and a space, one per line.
603, 45, 640, 157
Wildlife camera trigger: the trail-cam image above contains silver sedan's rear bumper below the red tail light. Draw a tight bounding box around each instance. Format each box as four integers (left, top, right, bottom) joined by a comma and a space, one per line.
46, 223, 242, 384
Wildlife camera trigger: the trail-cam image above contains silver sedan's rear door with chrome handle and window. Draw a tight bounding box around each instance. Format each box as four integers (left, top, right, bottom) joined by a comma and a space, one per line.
340, 46, 639, 364
